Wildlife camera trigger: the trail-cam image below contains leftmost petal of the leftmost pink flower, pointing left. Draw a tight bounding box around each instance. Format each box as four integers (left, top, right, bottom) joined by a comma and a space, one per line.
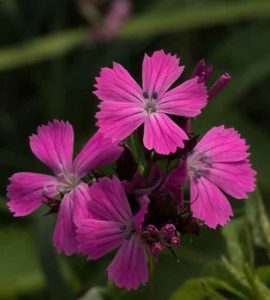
7, 172, 58, 217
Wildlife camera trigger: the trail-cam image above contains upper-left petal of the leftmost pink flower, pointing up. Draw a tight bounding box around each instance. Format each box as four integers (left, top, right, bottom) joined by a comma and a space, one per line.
30, 120, 74, 175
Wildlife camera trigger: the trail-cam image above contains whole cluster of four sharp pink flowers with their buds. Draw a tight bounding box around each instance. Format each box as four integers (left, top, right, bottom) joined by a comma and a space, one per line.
7, 51, 256, 290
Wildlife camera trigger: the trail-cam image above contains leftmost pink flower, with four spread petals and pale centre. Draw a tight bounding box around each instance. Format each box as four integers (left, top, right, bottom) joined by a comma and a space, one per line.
7, 120, 122, 255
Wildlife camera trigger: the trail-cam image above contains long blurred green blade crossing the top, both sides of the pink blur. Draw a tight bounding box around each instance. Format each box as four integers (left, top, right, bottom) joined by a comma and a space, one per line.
0, 0, 270, 71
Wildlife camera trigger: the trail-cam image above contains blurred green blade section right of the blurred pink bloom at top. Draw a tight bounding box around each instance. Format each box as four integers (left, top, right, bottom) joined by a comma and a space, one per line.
121, 1, 270, 38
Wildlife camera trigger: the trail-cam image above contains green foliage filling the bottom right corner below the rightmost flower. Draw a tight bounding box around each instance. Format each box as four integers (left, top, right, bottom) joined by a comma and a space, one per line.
170, 191, 270, 300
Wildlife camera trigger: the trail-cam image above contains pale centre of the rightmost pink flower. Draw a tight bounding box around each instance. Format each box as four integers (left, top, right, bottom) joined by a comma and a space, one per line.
187, 151, 212, 179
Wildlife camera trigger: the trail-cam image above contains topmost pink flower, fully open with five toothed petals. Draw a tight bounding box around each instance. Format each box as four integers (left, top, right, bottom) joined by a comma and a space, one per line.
94, 51, 207, 154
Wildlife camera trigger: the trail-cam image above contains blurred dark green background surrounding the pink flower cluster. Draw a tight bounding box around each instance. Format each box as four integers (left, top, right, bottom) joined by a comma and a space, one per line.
0, 0, 270, 300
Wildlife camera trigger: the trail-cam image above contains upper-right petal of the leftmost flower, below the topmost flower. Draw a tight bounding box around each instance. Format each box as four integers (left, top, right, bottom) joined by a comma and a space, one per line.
74, 132, 123, 177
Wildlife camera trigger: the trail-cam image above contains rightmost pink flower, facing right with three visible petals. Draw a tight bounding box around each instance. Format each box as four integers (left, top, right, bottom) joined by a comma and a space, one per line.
187, 126, 256, 228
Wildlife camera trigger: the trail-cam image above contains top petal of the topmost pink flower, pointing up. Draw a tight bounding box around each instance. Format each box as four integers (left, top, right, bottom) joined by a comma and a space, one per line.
142, 50, 184, 99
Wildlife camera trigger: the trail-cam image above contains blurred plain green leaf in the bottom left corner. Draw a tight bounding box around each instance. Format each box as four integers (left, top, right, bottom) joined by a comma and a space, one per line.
0, 227, 45, 299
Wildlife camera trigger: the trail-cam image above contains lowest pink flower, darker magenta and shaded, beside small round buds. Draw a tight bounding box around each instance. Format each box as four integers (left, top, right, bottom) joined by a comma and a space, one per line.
77, 177, 148, 290
